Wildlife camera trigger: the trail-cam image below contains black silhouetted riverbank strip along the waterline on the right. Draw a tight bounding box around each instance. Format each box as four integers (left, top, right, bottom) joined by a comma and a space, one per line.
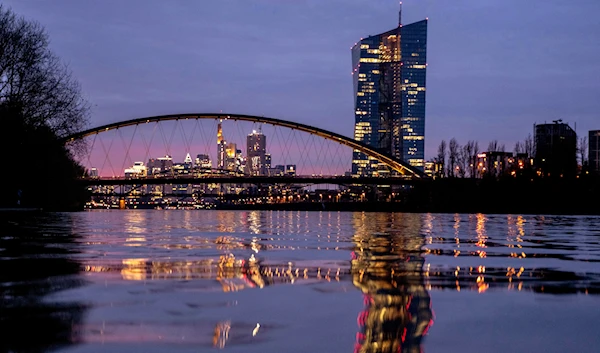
216, 176, 600, 215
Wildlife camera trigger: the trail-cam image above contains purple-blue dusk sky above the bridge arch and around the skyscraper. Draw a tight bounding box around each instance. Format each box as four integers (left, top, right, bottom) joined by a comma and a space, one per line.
3, 0, 600, 158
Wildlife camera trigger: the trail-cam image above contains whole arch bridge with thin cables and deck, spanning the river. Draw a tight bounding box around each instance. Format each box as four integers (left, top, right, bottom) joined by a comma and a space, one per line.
64, 113, 428, 205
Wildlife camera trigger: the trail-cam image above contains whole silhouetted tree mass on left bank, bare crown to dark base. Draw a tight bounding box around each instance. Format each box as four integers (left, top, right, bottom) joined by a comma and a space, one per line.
0, 5, 89, 207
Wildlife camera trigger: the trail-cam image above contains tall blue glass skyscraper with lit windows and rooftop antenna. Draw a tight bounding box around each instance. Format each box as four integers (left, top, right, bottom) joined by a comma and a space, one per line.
352, 4, 427, 175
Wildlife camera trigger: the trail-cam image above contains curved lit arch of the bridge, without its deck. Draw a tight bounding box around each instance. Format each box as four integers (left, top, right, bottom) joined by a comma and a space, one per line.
64, 114, 427, 179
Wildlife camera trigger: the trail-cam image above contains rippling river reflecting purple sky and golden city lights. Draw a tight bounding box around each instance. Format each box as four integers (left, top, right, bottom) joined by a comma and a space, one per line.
0, 210, 600, 352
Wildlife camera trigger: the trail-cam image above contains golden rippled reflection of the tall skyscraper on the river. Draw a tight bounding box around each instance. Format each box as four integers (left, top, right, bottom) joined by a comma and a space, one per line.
352, 214, 433, 353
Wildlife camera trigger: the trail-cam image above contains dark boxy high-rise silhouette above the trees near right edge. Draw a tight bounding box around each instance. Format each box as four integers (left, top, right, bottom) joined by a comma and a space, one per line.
534, 120, 577, 177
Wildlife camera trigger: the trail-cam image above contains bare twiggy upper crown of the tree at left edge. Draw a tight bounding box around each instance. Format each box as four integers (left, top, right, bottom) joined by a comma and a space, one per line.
0, 5, 89, 137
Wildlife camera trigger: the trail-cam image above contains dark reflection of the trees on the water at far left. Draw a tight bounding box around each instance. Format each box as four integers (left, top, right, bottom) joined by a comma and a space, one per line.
0, 213, 85, 352
